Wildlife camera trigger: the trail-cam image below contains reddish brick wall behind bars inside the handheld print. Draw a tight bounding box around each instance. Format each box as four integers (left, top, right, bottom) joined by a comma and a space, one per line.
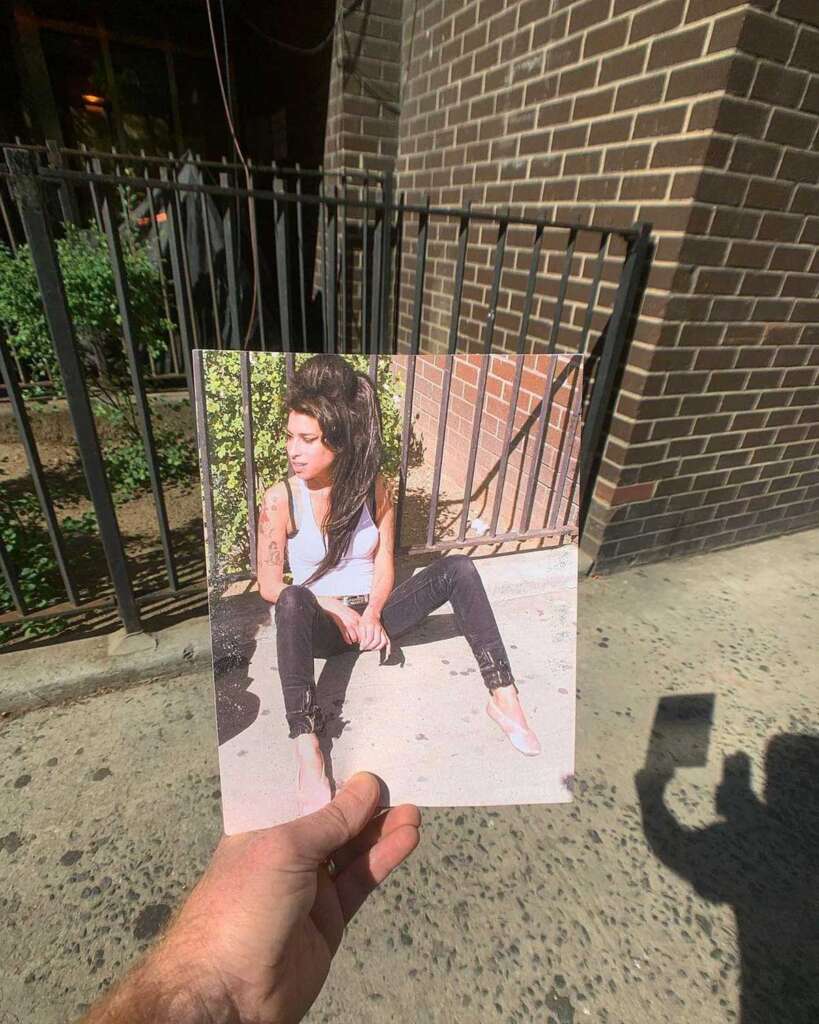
396, 355, 583, 532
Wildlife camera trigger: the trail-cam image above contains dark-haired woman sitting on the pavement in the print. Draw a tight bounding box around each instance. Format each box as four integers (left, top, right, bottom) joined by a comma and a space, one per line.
258, 355, 541, 814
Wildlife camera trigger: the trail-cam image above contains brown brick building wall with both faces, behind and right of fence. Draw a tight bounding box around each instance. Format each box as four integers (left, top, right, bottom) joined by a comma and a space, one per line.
329, 0, 819, 570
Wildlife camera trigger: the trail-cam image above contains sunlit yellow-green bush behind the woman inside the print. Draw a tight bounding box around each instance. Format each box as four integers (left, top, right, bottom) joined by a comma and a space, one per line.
205, 352, 402, 578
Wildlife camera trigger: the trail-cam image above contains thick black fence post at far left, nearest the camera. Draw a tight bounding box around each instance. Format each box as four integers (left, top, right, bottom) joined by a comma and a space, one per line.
4, 147, 142, 633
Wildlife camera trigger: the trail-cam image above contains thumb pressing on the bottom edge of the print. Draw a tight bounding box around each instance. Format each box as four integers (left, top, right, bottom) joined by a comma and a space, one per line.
288, 772, 381, 865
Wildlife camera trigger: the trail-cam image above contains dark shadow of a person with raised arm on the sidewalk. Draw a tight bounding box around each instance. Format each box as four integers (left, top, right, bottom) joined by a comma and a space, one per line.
635, 733, 819, 1024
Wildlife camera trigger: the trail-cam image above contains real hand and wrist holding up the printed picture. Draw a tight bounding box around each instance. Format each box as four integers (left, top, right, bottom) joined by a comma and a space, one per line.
85, 772, 421, 1024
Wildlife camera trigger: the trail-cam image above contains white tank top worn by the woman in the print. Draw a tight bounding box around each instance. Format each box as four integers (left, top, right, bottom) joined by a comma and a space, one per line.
288, 477, 379, 597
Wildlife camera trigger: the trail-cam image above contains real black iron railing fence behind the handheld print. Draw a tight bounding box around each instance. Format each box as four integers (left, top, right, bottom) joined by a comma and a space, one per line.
0, 146, 650, 632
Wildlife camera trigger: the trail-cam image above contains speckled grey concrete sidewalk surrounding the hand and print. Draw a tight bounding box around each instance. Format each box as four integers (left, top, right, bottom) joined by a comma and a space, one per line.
0, 530, 819, 1024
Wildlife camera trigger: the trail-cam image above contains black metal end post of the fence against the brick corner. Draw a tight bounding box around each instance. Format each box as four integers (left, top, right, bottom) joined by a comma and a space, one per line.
578, 223, 651, 508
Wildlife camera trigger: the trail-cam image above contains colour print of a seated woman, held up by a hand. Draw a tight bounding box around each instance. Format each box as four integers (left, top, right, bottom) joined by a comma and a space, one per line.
195, 352, 583, 834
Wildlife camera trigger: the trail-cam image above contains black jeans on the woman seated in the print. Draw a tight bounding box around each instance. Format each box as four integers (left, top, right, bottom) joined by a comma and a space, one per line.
275, 555, 514, 737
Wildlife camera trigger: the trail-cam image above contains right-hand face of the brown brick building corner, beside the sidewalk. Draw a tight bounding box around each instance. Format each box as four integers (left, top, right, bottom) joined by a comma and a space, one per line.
587, 0, 819, 568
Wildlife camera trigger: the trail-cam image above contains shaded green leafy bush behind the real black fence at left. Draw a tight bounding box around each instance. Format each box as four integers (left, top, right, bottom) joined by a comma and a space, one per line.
0, 225, 196, 643
